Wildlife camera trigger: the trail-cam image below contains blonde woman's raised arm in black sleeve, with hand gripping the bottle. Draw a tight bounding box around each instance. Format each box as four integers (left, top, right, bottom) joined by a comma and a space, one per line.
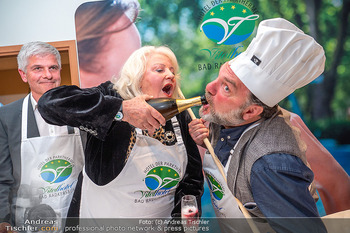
38, 81, 165, 140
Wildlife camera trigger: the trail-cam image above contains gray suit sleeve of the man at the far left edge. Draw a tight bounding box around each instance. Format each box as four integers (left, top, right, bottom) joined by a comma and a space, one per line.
0, 114, 14, 223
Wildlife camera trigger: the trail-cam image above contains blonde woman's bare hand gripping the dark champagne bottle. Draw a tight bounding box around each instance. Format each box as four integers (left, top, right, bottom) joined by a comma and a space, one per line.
123, 95, 165, 135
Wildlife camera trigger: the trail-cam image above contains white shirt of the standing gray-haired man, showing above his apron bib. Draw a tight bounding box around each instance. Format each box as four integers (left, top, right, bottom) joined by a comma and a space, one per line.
30, 95, 68, 137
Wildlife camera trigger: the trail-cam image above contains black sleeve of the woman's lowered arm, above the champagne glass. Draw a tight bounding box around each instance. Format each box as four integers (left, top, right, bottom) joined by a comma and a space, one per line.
172, 111, 204, 218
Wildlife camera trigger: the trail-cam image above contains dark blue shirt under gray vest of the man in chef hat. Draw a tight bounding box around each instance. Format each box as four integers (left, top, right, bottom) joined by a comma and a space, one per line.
214, 125, 324, 229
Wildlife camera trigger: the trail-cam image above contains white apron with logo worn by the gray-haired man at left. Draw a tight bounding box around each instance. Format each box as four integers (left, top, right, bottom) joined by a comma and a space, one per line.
16, 95, 84, 229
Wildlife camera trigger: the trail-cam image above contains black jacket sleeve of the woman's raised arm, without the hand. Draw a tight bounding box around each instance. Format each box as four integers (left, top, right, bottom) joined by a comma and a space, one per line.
38, 81, 123, 140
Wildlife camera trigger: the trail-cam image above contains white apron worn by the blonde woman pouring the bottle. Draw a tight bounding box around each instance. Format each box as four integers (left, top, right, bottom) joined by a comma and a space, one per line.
80, 117, 187, 218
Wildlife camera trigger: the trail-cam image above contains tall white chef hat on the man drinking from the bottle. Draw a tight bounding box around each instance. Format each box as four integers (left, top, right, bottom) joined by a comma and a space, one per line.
229, 18, 326, 107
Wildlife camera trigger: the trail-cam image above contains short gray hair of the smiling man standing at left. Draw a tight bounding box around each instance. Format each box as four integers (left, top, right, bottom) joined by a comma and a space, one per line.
17, 41, 61, 72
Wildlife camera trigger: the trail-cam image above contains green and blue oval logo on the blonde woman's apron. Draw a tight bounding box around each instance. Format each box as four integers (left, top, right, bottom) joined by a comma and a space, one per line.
145, 166, 180, 190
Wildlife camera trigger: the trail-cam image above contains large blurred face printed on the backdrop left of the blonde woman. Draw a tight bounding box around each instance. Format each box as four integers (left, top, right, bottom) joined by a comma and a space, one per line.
75, 0, 141, 88
